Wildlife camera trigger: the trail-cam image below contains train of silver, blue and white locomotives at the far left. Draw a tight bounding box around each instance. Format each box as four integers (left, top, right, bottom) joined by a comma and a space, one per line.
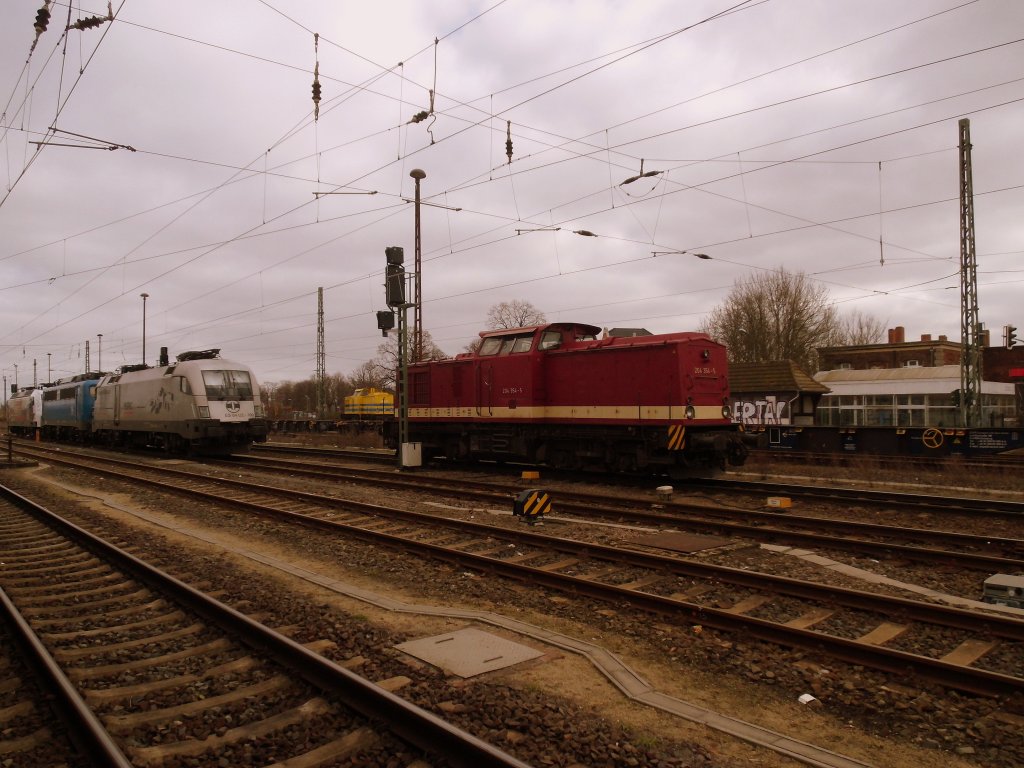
9, 349, 267, 454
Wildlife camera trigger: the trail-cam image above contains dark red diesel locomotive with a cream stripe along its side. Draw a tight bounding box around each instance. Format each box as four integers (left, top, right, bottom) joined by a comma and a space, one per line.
389, 323, 748, 476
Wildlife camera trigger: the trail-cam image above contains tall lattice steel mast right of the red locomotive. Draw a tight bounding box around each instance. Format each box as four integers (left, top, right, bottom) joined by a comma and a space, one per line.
959, 118, 983, 427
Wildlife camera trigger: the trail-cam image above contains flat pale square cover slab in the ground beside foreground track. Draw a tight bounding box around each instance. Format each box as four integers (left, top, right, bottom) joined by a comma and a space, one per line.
395, 629, 544, 678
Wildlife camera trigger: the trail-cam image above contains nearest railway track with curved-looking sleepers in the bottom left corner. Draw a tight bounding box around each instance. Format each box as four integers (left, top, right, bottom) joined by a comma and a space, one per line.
0, 486, 525, 768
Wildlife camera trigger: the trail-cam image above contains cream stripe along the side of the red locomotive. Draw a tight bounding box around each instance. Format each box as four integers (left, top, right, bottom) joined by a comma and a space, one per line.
409, 406, 722, 423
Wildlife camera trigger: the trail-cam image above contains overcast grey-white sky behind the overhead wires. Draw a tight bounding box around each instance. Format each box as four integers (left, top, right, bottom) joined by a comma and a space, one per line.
0, 0, 1024, 386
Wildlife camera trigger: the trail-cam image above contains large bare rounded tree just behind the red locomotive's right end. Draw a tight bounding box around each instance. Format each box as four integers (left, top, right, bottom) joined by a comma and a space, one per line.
700, 269, 842, 372
